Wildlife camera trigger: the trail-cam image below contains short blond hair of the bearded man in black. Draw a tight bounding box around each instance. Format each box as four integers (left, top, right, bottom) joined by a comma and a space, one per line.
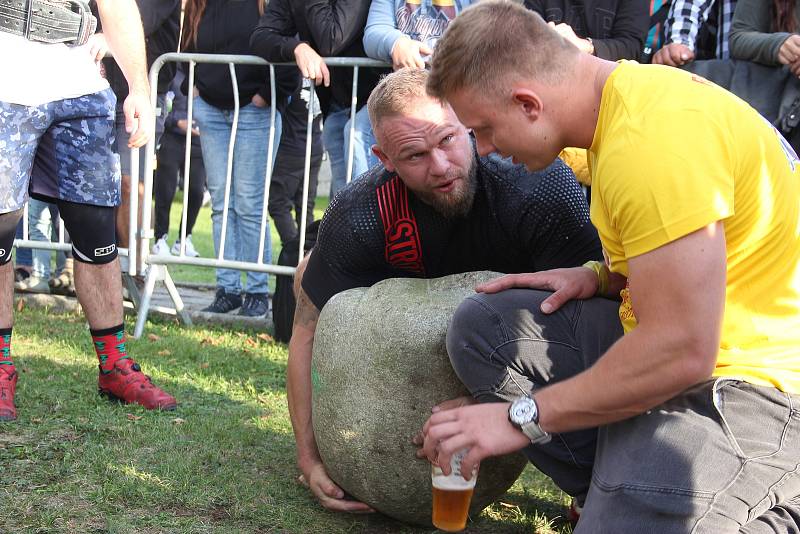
367, 68, 429, 131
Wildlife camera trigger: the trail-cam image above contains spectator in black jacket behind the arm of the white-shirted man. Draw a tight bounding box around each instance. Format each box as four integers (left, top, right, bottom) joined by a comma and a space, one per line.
103, 0, 181, 262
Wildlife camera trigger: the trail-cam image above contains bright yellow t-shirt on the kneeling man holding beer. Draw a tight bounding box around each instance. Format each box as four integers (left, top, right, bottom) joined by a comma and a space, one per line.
588, 62, 800, 393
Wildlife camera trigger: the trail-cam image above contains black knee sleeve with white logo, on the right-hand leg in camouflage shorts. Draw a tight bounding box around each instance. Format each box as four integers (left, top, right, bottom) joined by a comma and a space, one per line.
57, 200, 117, 264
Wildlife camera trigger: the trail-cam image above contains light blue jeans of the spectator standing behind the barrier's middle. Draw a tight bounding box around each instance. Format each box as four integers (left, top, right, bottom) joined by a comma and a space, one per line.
194, 97, 281, 294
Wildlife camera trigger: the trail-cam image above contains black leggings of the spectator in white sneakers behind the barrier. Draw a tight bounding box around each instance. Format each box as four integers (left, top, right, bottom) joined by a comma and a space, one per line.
153, 132, 206, 239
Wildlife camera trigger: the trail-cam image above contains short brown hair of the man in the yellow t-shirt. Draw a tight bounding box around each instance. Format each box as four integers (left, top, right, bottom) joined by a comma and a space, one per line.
427, 0, 580, 100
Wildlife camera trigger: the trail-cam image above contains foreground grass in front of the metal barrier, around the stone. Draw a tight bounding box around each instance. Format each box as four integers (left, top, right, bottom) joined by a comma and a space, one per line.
0, 308, 570, 534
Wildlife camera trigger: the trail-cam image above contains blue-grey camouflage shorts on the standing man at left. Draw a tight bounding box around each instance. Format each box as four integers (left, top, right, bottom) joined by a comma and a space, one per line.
0, 89, 120, 213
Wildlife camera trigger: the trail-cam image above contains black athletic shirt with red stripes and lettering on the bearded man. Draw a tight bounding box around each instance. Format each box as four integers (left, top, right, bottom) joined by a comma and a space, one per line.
303, 155, 602, 309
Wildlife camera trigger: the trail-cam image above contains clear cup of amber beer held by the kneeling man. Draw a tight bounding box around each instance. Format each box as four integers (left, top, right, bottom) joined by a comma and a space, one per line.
431, 449, 478, 532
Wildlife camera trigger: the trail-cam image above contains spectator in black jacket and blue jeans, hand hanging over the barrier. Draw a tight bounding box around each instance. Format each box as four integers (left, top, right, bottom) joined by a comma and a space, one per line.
251, 0, 388, 198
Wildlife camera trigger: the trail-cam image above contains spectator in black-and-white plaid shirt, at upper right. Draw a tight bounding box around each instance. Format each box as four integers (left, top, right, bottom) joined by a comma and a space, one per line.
653, 0, 736, 67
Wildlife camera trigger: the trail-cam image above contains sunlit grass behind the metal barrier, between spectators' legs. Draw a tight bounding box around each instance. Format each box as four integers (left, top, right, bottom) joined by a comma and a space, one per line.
159, 197, 328, 290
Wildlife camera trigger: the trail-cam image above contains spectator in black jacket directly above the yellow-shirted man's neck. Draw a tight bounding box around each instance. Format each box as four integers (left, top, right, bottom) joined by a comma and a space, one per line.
525, 0, 650, 61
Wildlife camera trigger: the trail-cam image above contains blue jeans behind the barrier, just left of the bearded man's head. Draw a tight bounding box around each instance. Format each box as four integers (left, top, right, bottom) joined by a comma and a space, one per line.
322, 104, 378, 198
